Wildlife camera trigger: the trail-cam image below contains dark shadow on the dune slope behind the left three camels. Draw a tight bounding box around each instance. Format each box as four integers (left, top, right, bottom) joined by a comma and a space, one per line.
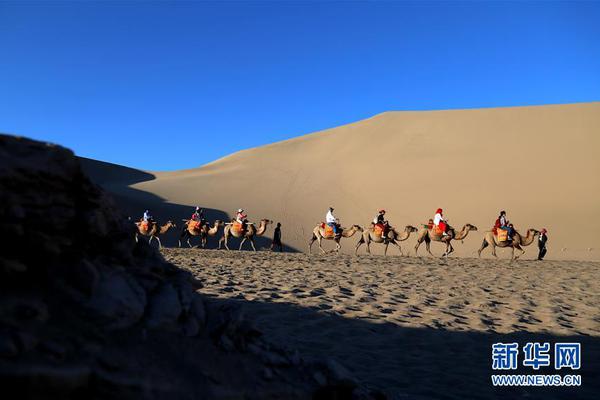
79, 157, 297, 252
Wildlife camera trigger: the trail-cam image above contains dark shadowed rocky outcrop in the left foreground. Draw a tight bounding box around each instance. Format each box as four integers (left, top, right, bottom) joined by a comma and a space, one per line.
0, 135, 380, 399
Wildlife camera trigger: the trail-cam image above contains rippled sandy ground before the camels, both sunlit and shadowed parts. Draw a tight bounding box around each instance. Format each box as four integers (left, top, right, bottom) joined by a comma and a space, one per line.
163, 249, 600, 398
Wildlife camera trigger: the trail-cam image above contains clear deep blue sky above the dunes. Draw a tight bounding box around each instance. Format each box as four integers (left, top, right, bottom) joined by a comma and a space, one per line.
0, 0, 600, 170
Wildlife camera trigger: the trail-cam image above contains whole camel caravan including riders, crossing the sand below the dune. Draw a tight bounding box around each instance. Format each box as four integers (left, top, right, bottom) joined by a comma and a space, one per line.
135, 207, 547, 260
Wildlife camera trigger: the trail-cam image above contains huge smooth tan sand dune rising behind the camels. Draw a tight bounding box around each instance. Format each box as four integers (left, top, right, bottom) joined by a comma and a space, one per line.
84, 103, 600, 260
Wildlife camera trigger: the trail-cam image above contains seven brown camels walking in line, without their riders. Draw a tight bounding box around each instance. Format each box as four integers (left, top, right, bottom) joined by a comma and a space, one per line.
135, 219, 539, 260
